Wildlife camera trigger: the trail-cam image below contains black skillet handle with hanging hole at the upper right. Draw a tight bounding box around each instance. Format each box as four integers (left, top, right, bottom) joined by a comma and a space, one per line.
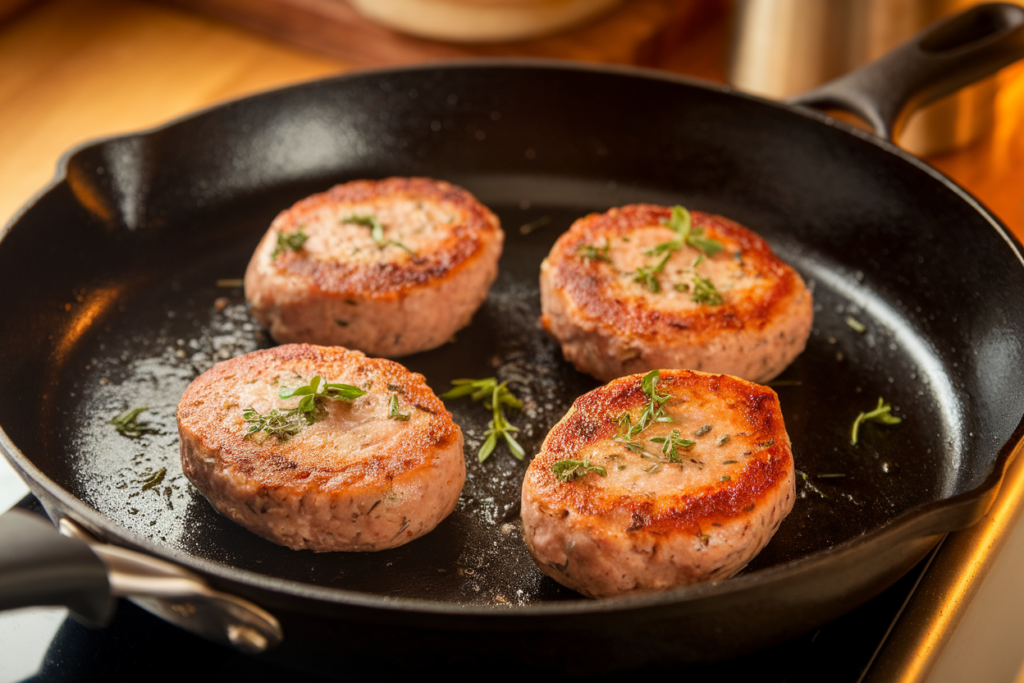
787, 3, 1024, 141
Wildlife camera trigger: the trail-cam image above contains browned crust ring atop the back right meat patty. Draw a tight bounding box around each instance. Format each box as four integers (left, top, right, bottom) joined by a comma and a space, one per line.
542, 204, 805, 345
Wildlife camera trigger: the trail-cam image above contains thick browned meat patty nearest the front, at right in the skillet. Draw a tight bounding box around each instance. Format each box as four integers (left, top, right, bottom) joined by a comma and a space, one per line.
522, 370, 795, 598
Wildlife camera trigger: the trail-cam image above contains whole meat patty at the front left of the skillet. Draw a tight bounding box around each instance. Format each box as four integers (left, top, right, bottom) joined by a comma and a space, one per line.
177, 344, 466, 552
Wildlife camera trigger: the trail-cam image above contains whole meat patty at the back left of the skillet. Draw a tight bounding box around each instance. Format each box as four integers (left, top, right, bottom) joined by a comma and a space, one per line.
245, 178, 504, 357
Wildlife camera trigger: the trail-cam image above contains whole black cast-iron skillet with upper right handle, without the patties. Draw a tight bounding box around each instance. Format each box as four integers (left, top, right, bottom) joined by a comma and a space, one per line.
0, 5, 1024, 674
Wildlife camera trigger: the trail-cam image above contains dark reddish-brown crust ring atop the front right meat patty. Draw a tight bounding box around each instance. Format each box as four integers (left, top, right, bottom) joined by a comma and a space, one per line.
526, 370, 793, 536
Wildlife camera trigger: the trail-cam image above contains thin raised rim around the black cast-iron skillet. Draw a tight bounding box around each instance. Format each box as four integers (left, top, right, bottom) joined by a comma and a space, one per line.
0, 57, 1024, 622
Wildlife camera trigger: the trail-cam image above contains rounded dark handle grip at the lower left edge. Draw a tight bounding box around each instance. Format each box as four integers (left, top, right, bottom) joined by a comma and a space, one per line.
0, 509, 116, 626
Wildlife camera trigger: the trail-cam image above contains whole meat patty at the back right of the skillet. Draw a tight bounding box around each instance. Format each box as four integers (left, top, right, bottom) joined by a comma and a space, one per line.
541, 204, 813, 382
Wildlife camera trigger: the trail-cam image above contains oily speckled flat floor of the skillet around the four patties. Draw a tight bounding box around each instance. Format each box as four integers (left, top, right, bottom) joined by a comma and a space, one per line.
44, 183, 956, 605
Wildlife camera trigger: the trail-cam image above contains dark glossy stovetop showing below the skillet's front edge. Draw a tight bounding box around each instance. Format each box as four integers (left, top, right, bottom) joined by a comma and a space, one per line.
0, 497, 934, 683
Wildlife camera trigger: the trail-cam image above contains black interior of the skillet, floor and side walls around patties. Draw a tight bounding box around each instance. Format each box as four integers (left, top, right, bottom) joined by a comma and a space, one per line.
0, 66, 1024, 605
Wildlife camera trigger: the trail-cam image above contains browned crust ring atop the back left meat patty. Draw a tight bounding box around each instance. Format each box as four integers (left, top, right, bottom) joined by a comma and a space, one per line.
266, 177, 501, 299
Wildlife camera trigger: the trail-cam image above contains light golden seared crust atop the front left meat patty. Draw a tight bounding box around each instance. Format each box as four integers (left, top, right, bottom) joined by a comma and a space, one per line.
177, 344, 461, 497
